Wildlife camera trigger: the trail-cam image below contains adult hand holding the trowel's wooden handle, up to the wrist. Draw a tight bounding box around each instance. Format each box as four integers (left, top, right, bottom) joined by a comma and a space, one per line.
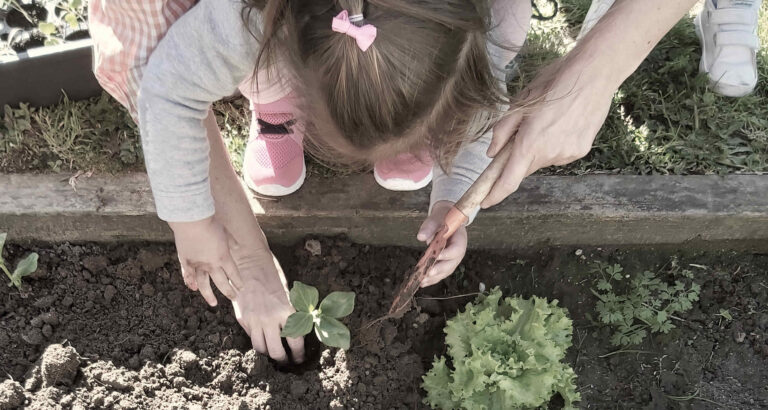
481, 60, 616, 208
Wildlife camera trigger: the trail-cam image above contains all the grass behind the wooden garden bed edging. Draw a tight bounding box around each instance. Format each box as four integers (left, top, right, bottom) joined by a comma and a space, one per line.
0, 0, 768, 176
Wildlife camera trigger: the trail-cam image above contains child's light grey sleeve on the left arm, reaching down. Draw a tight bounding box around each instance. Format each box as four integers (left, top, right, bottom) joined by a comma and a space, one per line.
138, 0, 259, 222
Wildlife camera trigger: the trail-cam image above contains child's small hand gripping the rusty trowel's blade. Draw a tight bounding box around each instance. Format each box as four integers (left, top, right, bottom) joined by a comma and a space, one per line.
416, 201, 467, 288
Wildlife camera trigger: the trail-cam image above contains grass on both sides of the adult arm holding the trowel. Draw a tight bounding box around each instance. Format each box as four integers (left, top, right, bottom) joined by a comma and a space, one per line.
523, 0, 768, 174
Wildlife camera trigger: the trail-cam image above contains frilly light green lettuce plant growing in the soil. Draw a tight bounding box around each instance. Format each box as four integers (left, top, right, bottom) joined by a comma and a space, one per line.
422, 287, 580, 410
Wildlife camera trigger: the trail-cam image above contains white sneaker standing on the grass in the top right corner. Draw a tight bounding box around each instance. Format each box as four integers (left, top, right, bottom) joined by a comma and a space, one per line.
695, 0, 761, 97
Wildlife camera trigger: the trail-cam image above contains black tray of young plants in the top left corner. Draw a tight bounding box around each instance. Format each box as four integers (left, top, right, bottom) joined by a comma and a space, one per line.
0, 0, 102, 110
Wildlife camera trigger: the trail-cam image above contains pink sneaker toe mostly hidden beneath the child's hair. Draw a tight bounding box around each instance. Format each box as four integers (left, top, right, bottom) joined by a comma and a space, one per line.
373, 150, 433, 191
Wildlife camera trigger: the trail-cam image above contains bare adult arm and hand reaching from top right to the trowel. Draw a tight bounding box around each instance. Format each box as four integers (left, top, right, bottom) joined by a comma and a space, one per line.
482, 0, 696, 208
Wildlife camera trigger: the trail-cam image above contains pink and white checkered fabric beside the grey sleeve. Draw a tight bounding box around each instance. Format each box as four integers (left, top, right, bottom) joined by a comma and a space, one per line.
88, 0, 197, 121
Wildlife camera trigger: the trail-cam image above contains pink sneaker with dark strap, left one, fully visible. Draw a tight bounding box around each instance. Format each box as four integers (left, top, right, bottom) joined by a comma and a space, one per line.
243, 95, 307, 196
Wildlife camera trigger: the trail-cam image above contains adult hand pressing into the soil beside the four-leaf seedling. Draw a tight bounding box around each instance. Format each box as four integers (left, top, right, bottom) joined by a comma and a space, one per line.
230, 242, 304, 363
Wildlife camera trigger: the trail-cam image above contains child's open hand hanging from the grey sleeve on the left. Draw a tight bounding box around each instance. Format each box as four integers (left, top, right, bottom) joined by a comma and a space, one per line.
169, 217, 243, 306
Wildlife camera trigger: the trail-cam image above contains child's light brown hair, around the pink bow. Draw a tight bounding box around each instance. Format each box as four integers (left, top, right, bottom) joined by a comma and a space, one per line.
244, 0, 508, 168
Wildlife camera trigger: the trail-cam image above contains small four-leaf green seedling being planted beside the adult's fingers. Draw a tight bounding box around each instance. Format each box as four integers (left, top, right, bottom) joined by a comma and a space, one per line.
281, 281, 355, 350
